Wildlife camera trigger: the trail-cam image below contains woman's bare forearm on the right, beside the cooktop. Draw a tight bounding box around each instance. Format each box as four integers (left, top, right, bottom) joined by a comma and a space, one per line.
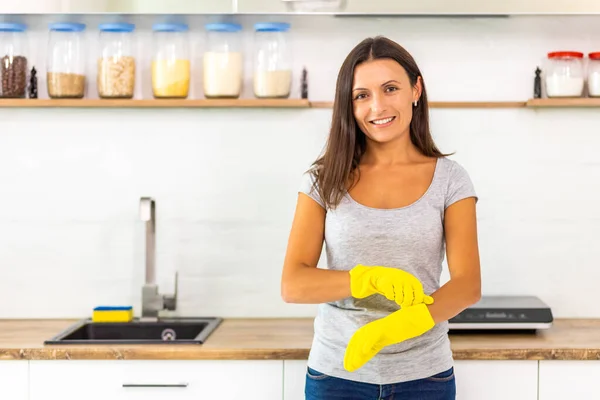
428, 278, 481, 324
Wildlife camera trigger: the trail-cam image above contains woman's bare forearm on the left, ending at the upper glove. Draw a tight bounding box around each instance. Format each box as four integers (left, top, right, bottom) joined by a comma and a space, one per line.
281, 266, 351, 304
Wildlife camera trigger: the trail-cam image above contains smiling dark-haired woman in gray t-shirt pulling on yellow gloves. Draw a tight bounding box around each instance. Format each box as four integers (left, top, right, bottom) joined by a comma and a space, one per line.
281, 37, 481, 400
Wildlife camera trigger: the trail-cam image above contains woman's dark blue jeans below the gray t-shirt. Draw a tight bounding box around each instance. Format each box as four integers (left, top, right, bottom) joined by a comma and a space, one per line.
304, 367, 456, 400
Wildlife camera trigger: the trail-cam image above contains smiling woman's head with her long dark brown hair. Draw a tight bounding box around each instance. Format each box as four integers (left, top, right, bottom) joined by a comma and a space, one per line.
314, 37, 448, 207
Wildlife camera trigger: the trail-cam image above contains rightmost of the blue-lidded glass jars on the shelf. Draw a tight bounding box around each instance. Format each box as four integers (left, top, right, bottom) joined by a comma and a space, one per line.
253, 23, 292, 98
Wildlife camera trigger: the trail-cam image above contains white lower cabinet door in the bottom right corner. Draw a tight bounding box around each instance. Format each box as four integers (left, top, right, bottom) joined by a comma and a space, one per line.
539, 360, 600, 400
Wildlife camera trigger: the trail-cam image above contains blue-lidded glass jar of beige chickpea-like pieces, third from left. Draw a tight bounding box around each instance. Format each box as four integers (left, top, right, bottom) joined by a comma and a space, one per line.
96, 23, 135, 99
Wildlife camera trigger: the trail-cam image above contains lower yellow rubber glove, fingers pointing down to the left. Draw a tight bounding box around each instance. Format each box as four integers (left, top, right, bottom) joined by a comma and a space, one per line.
344, 304, 435, 372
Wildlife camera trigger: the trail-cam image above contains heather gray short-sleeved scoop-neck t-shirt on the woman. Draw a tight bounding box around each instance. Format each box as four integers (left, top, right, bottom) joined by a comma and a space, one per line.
300, 157, 477, 385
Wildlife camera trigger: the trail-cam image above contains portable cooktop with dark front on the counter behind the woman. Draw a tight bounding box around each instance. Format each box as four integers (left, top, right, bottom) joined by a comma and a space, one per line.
448, 296, 554, 332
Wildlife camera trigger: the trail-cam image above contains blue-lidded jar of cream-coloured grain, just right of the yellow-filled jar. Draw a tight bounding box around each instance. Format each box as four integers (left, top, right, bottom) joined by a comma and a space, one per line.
203, 23, 244, 99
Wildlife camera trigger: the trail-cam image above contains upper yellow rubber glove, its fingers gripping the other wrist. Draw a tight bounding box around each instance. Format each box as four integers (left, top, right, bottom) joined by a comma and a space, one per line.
350, 264, 433, 307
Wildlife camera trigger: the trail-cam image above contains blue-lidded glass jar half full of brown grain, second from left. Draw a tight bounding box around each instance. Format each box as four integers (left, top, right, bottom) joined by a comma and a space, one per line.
46, 22, 86, 98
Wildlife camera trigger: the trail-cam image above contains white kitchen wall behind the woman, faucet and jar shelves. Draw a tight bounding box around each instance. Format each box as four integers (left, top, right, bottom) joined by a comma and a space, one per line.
0, 16, 600, 318
